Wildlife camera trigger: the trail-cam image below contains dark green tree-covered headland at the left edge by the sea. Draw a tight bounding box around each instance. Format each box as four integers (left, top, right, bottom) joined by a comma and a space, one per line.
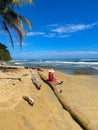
0, 43, 12, 61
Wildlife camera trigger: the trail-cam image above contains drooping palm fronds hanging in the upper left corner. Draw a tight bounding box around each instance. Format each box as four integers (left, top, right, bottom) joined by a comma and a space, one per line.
0, 0, 33, 47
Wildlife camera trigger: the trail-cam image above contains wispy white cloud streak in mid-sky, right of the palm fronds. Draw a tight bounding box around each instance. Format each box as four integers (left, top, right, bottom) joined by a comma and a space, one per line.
27, 22, 98, 38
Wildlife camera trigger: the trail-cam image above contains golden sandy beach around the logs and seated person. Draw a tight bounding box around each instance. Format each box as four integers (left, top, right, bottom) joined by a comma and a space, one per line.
0, 67, 98, 130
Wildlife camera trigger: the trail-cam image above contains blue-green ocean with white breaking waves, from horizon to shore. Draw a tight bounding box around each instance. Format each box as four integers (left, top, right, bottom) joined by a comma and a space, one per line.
8, 58, 98, 75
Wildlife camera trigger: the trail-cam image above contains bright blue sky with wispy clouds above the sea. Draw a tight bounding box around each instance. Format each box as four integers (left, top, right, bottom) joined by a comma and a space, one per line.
0, 0, 98, 59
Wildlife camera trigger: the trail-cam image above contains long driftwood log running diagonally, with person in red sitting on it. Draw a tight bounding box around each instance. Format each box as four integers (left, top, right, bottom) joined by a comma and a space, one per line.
38, 73, 96, 130
